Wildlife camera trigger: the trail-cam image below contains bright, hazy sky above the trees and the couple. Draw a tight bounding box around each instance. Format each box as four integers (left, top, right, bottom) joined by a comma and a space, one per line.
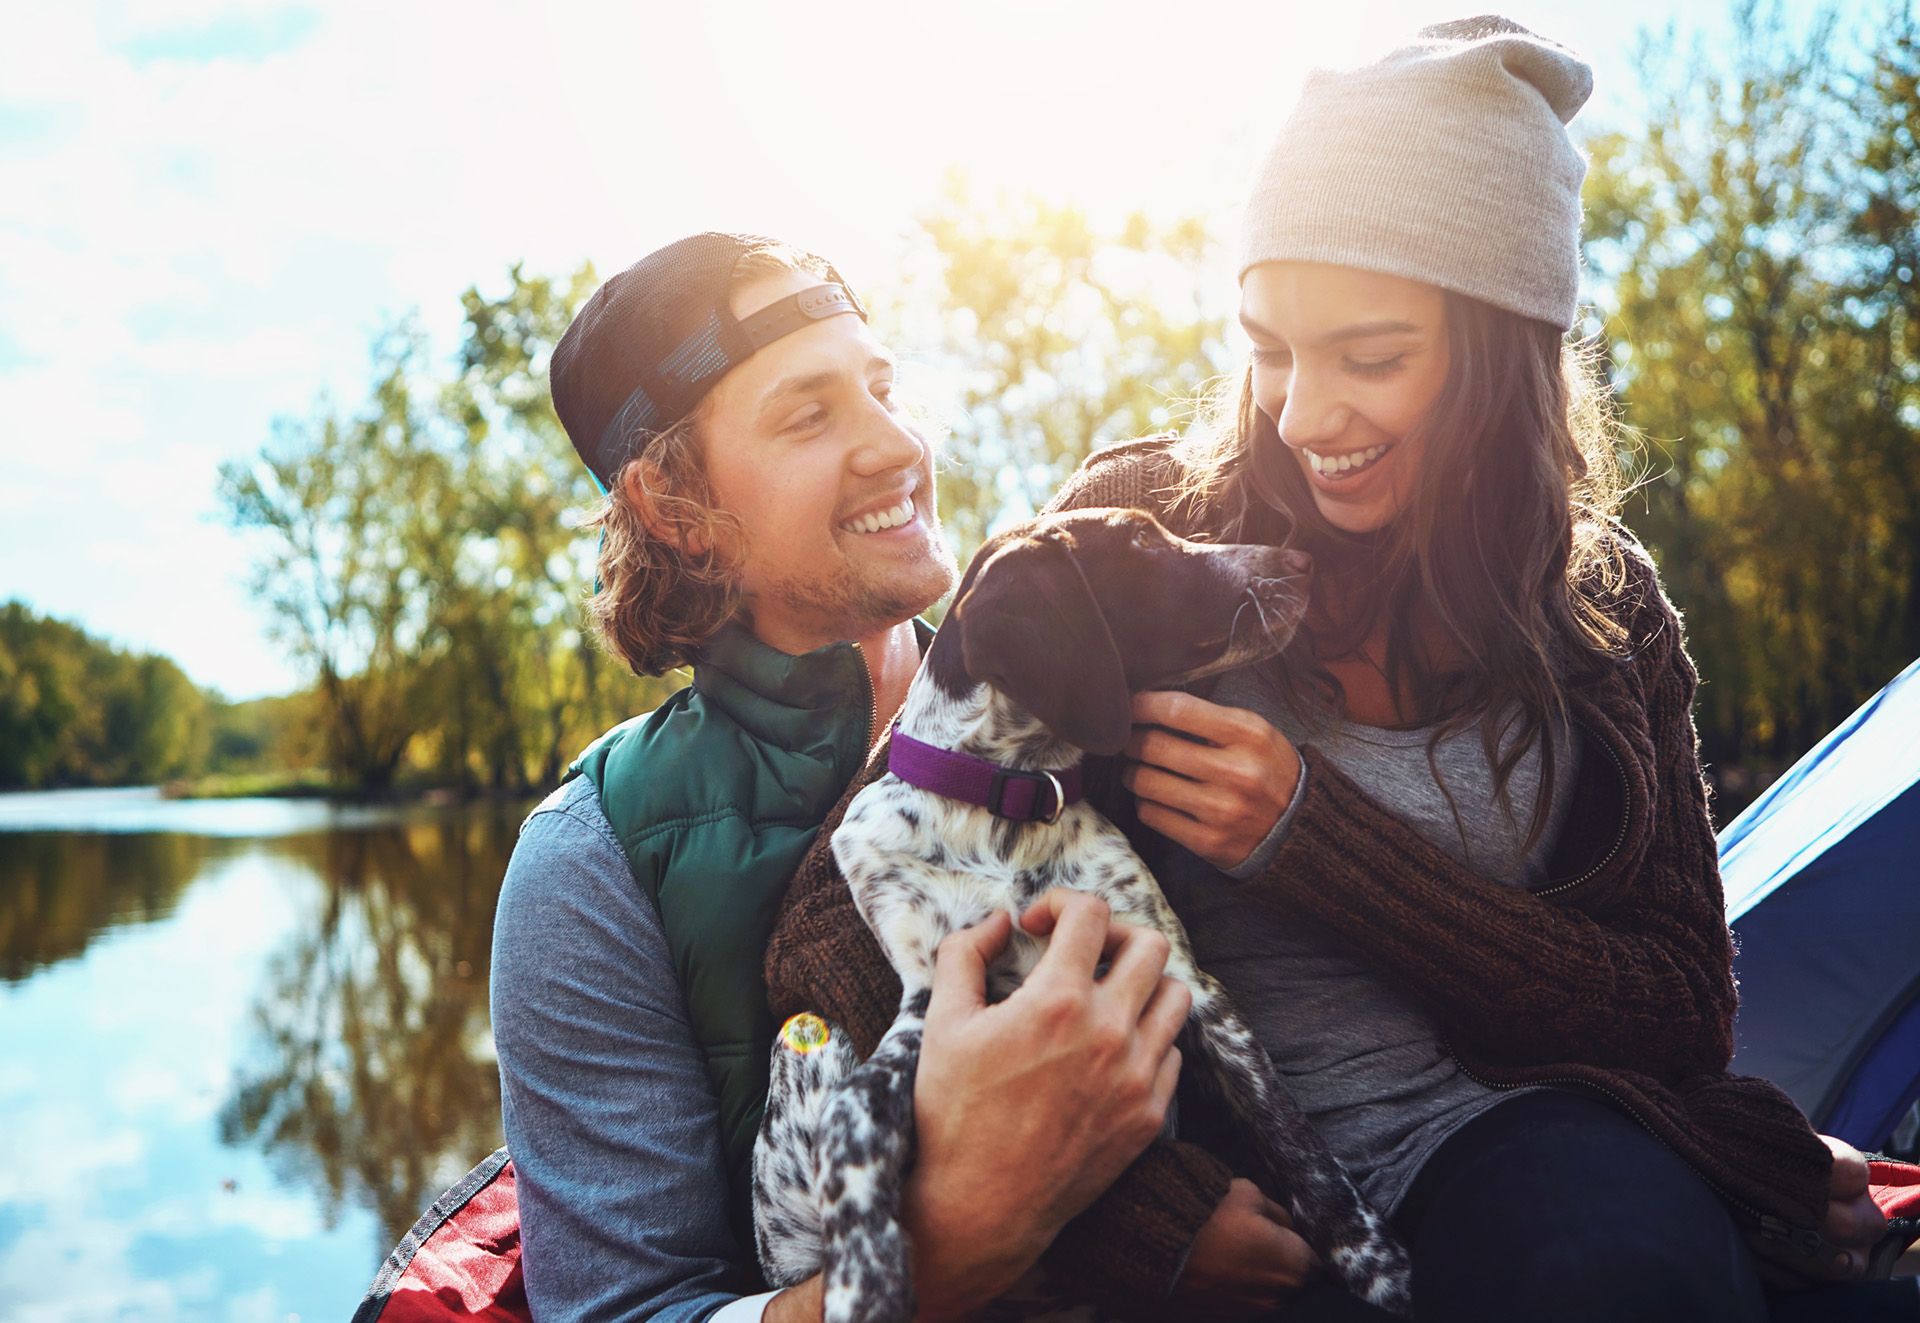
0, 0, 1843, 697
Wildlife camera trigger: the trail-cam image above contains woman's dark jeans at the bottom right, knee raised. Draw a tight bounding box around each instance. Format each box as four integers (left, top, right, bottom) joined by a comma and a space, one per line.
1281, 1091, 1920, 1323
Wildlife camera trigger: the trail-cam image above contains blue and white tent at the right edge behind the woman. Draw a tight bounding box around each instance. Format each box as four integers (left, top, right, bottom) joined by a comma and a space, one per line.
1720, 662, 1920, 1150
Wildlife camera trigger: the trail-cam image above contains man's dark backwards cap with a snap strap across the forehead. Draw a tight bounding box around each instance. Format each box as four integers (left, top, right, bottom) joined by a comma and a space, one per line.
549, 232, 866, 490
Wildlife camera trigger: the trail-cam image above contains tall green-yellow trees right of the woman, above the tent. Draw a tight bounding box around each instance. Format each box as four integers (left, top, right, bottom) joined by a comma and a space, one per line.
1586, 2, 1920, 762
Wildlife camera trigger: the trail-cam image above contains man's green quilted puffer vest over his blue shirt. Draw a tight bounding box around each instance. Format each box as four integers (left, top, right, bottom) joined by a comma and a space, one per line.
570, 620, 933, 1254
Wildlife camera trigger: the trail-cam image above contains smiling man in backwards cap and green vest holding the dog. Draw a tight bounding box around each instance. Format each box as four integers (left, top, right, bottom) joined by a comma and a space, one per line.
492, 234, 1267, 1323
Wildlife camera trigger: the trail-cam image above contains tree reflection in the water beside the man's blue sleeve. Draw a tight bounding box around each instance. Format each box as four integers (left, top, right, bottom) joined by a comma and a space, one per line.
221, 808, 520, 1244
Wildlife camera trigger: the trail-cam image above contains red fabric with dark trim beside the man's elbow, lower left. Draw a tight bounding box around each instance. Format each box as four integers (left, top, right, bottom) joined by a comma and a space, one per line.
353, 1148, 532, 1323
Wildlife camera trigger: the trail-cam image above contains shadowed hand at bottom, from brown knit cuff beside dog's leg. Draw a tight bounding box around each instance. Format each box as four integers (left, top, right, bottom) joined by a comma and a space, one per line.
1173, 1177, 1319, 1319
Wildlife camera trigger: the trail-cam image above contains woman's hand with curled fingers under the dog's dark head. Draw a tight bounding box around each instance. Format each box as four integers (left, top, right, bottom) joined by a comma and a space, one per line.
1121, 691, 1300, 868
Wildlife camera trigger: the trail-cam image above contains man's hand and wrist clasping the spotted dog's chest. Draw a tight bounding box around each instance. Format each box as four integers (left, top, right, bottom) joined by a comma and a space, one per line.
902, 891, 1192, 1317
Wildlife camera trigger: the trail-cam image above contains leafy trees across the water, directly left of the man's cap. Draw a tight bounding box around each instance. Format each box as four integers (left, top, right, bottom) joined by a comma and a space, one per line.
221, 267, 672, 793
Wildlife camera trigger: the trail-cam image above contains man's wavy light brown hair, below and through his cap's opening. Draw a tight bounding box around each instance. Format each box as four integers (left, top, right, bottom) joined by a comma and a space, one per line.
586, 244, 833, 676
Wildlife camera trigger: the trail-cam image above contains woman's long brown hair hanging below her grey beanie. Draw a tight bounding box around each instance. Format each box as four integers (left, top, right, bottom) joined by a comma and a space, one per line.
1177, 294, 1624, 853
